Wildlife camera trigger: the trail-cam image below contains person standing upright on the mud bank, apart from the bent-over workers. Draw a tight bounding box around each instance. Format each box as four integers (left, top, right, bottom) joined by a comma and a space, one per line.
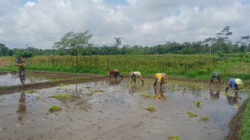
16, 56, 26, 84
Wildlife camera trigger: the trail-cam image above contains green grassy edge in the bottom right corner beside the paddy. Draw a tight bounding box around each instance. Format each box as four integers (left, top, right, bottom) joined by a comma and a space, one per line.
238, 93, 250, 140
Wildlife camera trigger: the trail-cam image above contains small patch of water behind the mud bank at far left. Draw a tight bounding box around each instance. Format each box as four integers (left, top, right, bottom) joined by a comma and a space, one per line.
0, 73, 48, 86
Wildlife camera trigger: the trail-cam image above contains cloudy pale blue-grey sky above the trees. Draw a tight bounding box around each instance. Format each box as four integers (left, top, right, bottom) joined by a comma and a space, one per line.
0, 0, 250, 49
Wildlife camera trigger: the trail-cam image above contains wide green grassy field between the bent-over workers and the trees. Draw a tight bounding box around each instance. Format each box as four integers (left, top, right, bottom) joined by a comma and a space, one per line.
0, 55, 250, 80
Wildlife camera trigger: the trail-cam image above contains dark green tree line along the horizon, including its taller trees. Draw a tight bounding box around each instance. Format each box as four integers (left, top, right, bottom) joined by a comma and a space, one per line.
0, 26, 250, 59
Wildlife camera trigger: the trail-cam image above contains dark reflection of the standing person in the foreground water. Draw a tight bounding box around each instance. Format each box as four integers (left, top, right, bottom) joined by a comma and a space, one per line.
17, 92, 26, 121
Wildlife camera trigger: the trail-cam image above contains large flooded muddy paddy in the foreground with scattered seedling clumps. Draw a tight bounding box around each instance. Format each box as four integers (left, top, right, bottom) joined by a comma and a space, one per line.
0, 79, 247, 140
